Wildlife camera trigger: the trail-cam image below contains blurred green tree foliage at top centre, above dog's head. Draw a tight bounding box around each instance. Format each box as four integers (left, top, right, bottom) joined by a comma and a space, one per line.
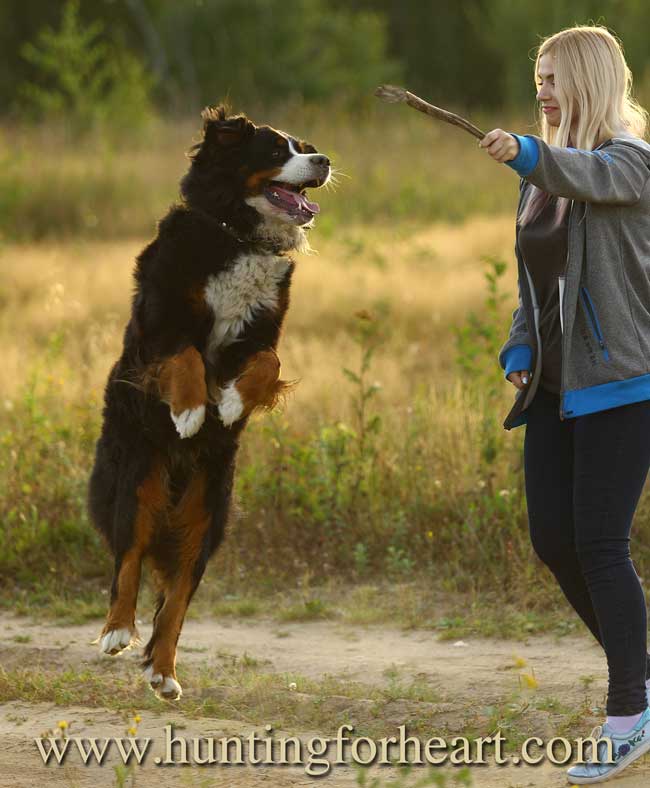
139, 0, 401, 109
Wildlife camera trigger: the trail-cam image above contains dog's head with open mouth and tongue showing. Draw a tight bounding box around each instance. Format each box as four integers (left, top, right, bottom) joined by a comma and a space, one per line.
181, 106, 331, 239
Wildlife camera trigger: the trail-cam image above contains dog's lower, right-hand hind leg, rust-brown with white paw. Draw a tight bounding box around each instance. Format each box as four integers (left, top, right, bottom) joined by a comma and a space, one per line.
142, 465, 232, 700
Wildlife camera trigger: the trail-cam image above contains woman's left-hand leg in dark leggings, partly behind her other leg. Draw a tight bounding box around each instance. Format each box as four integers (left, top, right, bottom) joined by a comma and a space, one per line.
524, 388, 608, 648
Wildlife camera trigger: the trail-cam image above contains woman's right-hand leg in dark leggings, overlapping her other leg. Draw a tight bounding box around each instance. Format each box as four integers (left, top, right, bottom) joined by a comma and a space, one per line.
573, 401, 650, 716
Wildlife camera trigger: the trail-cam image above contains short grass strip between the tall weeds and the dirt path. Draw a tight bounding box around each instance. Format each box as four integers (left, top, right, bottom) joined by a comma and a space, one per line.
0, 566, 582, 649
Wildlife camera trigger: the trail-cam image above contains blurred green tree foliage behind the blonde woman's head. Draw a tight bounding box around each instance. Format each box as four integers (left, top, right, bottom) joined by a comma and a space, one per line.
332, 0, 650, 119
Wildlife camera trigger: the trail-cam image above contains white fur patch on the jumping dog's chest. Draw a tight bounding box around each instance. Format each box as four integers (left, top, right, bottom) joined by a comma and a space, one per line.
204, 254, 291, 352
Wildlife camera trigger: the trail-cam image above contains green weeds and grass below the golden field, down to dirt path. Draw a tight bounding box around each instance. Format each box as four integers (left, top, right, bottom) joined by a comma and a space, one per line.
0, 336, 616, 638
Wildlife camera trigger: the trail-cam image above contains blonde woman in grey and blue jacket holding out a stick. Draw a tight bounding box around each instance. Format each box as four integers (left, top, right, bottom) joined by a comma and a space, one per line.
479, 26, 650, 784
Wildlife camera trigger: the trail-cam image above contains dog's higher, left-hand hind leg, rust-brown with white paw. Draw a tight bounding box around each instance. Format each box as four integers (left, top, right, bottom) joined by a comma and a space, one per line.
99, 462, 166, 655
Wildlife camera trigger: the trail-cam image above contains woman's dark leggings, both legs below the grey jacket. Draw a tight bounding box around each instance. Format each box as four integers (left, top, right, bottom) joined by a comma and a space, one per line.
524, 387, 650, 716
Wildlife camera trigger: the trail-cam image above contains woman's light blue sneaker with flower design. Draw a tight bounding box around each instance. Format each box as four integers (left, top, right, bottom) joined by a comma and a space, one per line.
567, 707, 650, 785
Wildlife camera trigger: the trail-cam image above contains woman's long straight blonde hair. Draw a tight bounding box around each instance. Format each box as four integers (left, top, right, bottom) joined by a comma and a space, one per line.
518, 25, 648, 226
